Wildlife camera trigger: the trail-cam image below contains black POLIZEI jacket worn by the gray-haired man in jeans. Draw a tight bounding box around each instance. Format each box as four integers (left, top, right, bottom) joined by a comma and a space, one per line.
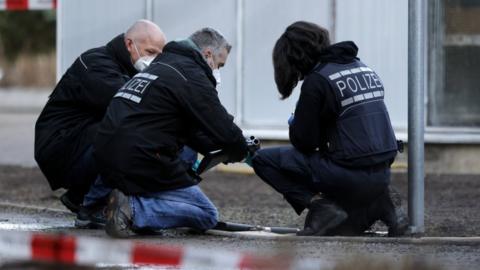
94, 42, 247, 195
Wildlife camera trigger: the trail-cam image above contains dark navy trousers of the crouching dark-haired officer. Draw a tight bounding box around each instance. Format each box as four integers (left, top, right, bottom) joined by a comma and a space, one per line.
252, 146, 390, 230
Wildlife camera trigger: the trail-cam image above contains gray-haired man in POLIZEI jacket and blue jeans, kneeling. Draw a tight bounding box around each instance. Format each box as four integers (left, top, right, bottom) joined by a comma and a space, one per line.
94, 28, 248, 237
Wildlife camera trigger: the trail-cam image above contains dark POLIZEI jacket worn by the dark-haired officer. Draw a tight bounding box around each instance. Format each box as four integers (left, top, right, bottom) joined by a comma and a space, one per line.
290, 42, 397, 167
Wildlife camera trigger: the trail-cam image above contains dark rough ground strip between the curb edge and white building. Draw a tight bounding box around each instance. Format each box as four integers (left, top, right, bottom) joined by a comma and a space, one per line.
0, 166, 480, 237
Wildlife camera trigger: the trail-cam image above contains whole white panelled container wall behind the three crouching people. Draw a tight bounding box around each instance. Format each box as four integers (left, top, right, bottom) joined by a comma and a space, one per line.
57, 0, 408, 139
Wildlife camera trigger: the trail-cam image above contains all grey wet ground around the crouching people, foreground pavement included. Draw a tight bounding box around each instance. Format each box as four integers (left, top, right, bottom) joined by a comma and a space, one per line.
0, 166, 480, 269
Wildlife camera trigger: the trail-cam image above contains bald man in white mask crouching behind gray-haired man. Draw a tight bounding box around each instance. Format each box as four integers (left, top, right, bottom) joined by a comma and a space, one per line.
35, 20, 166, 219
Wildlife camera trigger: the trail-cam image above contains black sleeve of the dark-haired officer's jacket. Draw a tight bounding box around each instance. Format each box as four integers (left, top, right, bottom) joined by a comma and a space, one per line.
289, 74, 337, 153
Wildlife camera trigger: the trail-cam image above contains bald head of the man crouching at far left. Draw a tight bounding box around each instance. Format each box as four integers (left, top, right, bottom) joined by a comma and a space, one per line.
125, 20, 167, 63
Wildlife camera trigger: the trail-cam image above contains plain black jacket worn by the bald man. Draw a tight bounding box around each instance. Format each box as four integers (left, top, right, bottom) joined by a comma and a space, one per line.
35, 34, 137, 189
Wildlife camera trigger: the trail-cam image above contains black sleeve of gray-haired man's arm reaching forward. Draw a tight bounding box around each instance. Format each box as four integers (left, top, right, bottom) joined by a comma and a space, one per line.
181, 79, 248, 162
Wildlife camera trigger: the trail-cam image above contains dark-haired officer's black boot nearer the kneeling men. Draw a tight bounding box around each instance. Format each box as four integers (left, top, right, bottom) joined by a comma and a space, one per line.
297, 199, 348, 236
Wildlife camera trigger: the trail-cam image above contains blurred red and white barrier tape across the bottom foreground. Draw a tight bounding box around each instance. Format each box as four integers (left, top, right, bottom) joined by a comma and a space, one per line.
0, 231, 330, 270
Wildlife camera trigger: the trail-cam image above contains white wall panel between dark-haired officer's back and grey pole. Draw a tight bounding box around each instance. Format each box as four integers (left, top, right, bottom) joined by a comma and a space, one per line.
335, 0, 408, 131
